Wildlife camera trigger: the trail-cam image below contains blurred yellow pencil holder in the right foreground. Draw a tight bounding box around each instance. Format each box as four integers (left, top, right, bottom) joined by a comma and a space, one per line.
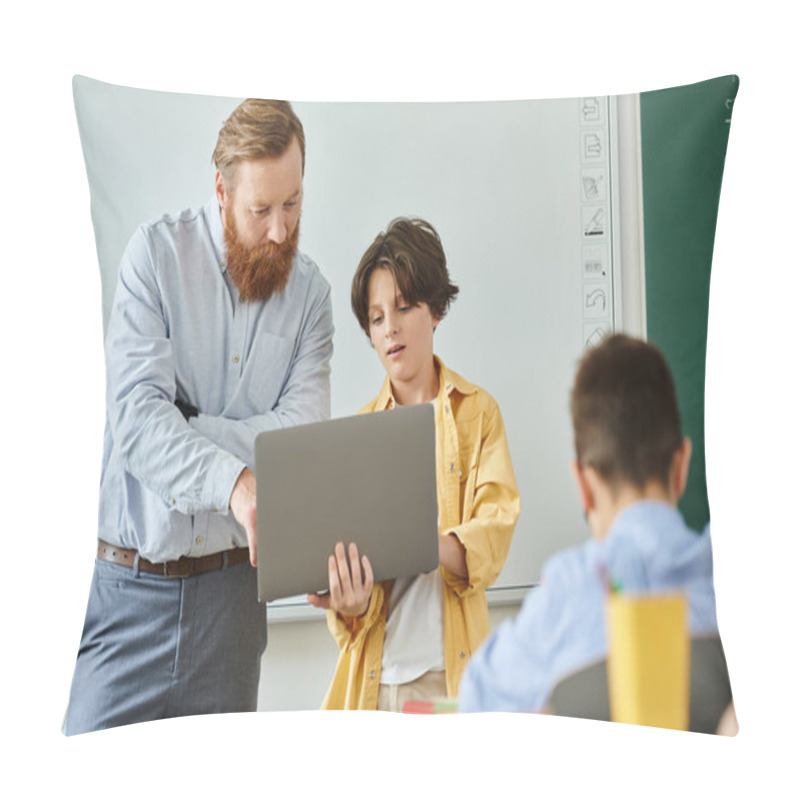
606, 592, 690, 731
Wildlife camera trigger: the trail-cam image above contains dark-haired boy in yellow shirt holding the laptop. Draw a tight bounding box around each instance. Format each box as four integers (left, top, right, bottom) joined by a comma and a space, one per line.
309, 218, 520, 711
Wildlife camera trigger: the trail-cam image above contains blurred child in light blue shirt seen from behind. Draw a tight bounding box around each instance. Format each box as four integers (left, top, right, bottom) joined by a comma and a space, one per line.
459, 334, 717, 711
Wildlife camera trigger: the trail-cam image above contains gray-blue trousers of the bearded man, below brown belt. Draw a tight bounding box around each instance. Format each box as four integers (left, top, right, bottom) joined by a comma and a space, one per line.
64, 560, 267, 736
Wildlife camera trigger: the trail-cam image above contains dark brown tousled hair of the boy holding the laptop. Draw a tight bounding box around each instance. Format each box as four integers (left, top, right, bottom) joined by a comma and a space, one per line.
350, 217, 458, 336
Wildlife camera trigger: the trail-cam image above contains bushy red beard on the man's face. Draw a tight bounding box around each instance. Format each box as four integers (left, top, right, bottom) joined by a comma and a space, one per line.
225, 214, 300, 302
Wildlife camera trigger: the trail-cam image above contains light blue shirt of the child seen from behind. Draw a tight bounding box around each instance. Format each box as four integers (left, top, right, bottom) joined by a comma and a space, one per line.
458, 501, 717, 711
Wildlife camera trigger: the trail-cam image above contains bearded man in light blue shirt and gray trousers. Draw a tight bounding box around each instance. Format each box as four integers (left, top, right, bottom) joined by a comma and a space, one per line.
64, 100, 333, 735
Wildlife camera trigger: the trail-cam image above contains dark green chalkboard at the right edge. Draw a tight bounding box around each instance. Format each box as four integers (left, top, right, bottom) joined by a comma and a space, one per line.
640, 75, 739, 529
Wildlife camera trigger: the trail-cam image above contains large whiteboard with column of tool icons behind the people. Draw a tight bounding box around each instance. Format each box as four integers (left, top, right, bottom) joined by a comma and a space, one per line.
73, 77, 646, 596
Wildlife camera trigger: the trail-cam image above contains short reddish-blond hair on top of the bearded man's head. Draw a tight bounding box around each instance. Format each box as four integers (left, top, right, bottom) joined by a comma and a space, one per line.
212, 98, 306, 188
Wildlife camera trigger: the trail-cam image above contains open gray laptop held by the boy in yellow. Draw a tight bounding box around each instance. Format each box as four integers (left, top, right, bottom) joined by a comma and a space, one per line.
256, 403, 439, 601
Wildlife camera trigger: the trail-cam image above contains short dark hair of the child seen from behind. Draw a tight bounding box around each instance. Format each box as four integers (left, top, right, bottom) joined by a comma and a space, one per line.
570, 334, 682, 492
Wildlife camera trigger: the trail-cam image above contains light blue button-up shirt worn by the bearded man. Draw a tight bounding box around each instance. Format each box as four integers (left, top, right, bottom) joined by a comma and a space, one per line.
98, 197, 333, 562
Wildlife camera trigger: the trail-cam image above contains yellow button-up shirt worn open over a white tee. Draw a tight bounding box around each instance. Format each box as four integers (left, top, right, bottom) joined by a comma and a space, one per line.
322, 358, 520, 709
